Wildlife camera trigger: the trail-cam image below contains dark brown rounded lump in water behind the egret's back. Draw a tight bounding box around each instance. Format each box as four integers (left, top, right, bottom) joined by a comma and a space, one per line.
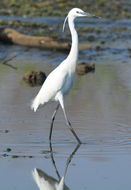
23, 71, 46, 86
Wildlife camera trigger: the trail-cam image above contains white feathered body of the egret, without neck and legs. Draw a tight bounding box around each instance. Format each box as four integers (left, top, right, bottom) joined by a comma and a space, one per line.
31, 61, 72, 111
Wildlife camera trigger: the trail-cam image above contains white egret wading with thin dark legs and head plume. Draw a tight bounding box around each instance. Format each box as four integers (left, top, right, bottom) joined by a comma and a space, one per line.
31, 8, 98, 144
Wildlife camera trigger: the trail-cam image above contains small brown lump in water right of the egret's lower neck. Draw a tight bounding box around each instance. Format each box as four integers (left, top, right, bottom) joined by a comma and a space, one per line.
76, 62, 95, 75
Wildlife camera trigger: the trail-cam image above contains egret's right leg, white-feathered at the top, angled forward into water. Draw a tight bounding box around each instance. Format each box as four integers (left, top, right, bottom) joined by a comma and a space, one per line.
59, 95, 81, 144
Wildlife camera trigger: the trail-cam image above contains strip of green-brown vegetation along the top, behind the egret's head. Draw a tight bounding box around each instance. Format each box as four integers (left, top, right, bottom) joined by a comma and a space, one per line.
0, 0, 131, 19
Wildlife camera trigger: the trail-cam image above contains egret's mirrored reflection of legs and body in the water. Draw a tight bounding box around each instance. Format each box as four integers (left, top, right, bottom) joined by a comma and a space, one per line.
32, 142, 80, 190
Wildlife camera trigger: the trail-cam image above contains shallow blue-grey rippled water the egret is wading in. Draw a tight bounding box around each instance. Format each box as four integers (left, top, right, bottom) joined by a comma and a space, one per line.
0, 18, 131, 190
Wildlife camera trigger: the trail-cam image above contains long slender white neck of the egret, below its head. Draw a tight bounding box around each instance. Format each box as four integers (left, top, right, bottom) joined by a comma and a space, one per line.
67, 16, 78, 63
